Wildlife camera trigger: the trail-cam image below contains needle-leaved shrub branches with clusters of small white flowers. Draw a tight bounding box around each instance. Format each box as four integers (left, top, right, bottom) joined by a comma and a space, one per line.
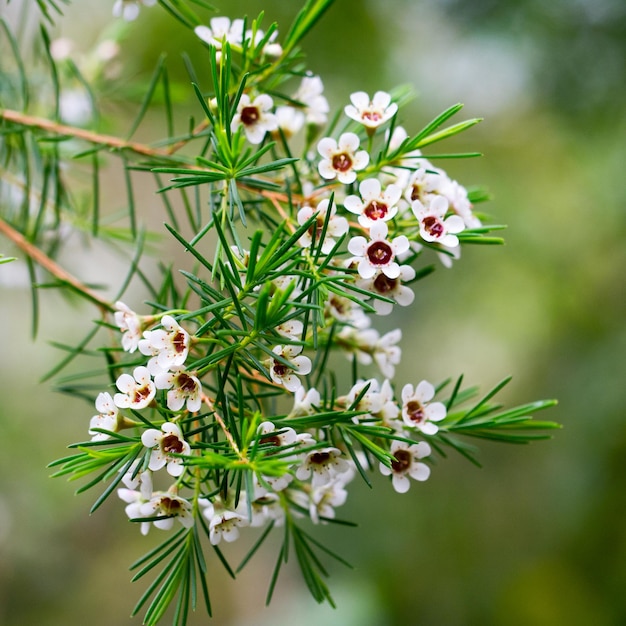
0, 0, 555, 624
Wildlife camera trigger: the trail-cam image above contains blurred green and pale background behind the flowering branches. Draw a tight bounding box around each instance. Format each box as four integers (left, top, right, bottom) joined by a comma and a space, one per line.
0, 0, 626, 626
